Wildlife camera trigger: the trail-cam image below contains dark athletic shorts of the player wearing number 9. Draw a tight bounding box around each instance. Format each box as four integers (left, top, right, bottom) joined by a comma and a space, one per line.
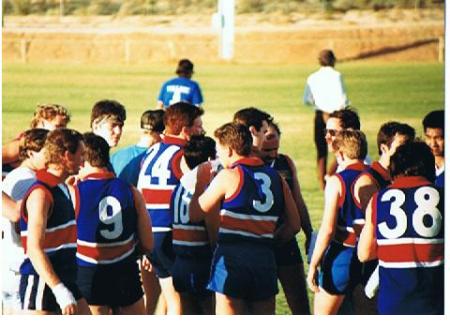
77, 261, 144, 308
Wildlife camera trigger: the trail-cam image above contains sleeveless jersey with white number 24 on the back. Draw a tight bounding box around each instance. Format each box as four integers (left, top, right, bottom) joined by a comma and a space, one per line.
138, 136, 186, 232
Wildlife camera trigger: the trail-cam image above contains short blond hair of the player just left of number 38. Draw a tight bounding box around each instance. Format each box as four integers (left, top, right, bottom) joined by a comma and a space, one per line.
333, 130, 367, 159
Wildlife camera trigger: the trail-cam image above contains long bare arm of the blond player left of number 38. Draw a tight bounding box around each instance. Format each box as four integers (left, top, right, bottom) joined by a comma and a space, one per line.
306, 175, 341, 292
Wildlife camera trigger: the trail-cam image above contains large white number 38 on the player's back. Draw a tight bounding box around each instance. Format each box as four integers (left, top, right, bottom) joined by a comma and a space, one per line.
378, 187, 442, 239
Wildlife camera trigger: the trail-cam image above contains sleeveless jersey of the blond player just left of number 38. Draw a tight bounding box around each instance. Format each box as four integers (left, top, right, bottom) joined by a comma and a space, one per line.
333, 162, 367, 247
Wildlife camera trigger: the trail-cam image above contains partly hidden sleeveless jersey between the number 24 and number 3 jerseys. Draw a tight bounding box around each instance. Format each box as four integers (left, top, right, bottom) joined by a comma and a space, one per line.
171, 167, 211, 258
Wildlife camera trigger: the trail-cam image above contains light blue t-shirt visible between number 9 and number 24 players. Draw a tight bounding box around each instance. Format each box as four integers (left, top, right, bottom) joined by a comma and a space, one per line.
111, 145, 148, 187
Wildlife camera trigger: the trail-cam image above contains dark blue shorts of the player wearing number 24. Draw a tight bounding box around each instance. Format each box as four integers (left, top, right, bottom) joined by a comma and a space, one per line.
148, 231, 175, 278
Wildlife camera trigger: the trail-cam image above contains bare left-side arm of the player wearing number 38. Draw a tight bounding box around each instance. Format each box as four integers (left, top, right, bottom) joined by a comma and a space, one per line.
358, 198, 377, 262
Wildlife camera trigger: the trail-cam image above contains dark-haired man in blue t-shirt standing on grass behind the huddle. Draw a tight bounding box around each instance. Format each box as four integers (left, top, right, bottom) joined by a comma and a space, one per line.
157, 59, 203, 109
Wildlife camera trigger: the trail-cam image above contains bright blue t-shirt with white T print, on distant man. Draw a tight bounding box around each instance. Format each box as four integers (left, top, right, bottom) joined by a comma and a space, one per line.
158, 77, 203, 108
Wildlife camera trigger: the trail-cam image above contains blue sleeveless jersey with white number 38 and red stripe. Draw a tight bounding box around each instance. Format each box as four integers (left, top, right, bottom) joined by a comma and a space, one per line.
371, 177, 444, 314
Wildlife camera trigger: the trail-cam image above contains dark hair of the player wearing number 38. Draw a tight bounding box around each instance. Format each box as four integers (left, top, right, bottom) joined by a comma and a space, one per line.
389, 140, 436, 182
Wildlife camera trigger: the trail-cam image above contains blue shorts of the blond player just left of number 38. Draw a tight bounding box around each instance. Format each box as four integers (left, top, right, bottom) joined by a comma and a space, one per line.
319, 241, 361, 295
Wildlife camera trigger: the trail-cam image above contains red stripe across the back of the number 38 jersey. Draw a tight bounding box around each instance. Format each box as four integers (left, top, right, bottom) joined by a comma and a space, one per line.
378, 243, 444, 262
